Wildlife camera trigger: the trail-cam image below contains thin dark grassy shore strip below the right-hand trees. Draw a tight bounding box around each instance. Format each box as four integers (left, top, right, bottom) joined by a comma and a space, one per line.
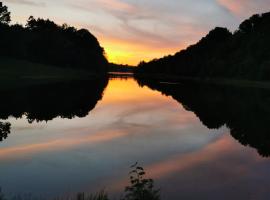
135, 74, 270, 89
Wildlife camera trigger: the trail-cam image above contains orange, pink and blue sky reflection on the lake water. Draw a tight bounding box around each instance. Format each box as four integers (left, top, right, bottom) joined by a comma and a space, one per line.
0, 79, 270, 200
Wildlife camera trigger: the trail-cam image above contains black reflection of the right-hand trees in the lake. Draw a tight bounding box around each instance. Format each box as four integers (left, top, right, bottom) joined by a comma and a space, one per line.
138, 79, 270, 157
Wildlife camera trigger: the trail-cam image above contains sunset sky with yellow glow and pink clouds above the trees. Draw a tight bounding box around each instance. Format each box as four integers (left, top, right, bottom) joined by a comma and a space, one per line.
3, 0, 270, 65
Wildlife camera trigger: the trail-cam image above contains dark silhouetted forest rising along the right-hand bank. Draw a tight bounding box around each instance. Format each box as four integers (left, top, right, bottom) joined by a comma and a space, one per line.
136, 13, 270, 80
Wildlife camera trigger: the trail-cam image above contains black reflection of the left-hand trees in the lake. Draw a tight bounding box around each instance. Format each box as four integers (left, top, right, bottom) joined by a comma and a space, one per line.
0, 78, 108, 123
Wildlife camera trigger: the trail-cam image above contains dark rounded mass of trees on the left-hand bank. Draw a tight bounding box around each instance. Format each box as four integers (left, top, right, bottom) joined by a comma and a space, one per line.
0, 2, 108, 73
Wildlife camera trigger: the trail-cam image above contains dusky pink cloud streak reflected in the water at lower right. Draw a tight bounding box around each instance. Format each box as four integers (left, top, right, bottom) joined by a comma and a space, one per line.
109, 133, 266, 192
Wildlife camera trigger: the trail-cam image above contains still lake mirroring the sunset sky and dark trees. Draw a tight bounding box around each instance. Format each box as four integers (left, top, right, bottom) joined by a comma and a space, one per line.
0, 77, 270, 200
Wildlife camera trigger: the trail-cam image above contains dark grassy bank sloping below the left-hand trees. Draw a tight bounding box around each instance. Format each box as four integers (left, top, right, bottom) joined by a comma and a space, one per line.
0, 57, 102, 89
